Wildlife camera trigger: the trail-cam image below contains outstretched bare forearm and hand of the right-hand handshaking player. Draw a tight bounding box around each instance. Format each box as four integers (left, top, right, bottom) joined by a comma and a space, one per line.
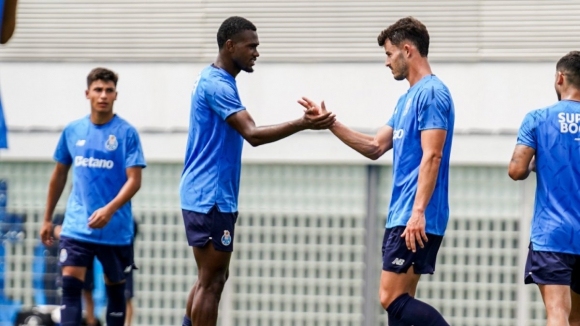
298, 97, 393, 160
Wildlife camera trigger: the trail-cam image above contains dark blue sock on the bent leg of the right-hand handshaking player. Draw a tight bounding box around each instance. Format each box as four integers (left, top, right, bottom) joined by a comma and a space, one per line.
387, 293, 449, 326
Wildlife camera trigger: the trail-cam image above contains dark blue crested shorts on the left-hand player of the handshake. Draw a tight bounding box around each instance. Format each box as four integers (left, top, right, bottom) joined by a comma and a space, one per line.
182, 206, 238, 252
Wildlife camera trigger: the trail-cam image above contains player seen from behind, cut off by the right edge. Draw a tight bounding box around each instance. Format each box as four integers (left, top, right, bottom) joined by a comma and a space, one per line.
509, 51, 580, 326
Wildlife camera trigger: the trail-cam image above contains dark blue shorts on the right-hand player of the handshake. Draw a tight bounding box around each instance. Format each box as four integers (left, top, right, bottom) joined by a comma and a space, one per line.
383, 226, 443, 274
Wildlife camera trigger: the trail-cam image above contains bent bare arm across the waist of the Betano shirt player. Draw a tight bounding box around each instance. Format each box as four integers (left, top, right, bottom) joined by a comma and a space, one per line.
89, 166, 143, 229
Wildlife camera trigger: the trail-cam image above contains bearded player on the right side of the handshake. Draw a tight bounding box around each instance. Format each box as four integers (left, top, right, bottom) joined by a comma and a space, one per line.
299, 17, 455, 326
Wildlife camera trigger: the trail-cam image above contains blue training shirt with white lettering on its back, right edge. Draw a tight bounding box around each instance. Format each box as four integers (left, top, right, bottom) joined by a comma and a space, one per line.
517, 100, 580, 255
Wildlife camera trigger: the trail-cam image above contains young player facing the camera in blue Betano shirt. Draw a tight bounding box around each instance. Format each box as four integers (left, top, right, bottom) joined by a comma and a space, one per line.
40, 68, 145, 326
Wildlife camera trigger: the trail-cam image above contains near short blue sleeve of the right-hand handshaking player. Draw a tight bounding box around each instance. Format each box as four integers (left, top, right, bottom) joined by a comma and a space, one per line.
417, 87, 452, 130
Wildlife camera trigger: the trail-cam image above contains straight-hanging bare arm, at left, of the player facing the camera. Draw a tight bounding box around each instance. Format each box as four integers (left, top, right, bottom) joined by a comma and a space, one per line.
40, 162, 70, 246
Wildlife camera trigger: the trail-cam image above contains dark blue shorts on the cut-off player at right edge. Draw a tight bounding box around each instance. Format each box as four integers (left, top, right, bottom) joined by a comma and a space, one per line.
524, 243, 580, 293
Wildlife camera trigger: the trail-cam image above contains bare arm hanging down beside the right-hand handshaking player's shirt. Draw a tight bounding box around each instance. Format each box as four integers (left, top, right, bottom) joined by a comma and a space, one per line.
401, 129, 447, 252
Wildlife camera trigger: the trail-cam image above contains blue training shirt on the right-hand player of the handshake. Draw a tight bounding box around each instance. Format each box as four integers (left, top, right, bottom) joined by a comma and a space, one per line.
386, 75, 455, 235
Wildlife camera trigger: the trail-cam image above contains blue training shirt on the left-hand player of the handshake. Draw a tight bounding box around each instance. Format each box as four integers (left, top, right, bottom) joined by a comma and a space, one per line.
179, 65, 246, 213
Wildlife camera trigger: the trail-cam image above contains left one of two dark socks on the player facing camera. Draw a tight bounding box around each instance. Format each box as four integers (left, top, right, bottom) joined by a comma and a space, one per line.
60, 276, 83, 326
